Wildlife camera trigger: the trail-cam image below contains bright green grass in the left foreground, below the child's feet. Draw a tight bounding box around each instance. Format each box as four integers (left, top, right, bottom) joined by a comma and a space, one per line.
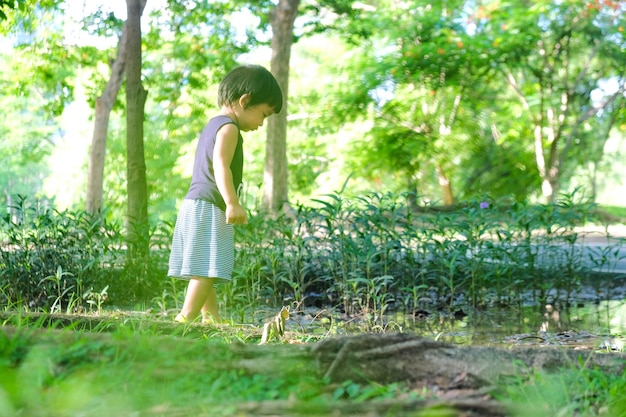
0, 316, 424, 417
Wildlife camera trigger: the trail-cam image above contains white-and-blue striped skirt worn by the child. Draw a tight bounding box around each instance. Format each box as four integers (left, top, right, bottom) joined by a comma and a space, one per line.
167, 199, 235, 282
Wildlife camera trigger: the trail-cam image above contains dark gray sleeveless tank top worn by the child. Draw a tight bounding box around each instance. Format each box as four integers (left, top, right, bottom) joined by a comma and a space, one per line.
185, 116, 243, 210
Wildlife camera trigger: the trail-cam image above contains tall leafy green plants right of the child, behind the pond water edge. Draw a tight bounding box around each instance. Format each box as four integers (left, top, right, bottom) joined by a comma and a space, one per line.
222, 190, 617, 320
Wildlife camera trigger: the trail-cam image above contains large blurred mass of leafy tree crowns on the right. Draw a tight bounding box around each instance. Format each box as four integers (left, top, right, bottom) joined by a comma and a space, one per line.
298, 1, 624, 201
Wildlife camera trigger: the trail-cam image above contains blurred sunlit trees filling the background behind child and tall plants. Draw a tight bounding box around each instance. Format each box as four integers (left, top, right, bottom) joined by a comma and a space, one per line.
0, 0, 626, 224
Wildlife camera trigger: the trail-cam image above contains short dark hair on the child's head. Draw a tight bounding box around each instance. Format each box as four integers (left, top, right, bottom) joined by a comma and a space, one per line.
217, 65, 283, 113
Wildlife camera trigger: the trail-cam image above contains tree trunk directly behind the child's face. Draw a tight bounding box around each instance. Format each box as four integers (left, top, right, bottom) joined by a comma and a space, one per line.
262, 0, 300, 213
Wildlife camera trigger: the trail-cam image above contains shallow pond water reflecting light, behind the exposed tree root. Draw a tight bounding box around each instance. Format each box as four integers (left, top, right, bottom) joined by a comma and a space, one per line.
292, 280, 626, 351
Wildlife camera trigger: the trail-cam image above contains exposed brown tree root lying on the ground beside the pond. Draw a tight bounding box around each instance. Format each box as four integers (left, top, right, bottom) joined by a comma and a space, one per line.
311, 334, 626, 388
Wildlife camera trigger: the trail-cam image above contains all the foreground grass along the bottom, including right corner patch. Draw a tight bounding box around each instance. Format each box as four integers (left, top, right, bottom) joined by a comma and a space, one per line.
0, 314, 626, 417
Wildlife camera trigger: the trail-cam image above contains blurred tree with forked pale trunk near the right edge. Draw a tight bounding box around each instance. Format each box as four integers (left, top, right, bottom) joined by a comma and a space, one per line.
473, 0, 626, 202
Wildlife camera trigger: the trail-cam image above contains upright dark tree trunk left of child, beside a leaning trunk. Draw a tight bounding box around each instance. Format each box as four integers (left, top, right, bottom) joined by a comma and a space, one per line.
126, 0, 149, 258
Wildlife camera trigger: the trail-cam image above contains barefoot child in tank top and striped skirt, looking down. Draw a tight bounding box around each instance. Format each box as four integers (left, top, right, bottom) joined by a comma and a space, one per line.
168, 65, 283, 323
